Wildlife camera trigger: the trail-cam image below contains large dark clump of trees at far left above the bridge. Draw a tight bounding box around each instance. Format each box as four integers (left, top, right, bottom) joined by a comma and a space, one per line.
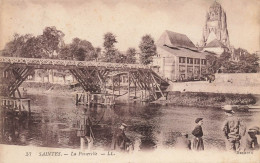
0, 27, 64, 58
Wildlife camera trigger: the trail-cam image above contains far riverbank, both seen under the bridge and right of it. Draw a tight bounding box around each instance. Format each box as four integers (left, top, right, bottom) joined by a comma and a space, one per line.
22, 82, 257, 107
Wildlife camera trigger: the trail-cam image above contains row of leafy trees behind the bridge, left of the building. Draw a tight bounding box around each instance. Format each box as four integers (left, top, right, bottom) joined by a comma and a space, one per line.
1, 26, 157, 65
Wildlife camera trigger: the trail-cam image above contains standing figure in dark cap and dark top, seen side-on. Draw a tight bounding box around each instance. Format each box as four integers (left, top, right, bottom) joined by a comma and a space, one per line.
192, 118, 204, 151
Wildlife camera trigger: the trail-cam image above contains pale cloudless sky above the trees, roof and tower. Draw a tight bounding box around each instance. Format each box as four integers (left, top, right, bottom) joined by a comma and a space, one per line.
0, 0, 260, 52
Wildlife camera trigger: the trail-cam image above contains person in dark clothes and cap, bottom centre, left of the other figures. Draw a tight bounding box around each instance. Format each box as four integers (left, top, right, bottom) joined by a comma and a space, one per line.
111, 123, 131, 151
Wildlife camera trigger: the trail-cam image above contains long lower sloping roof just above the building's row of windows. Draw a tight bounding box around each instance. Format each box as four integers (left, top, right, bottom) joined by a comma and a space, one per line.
157, 45, 208, 58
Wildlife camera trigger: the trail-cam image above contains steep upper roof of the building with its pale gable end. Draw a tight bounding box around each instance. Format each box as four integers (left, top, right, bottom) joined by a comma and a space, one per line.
156, 30, 197, 50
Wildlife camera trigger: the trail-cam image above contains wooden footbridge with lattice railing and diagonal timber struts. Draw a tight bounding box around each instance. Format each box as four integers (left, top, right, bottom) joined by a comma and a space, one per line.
0, 57, 169, 101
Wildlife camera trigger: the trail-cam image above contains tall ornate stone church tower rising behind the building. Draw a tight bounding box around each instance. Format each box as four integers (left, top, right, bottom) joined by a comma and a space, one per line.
201, 1, 230, 48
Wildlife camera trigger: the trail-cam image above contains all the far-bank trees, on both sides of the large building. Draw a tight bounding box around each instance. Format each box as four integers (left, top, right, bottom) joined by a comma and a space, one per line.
1, 26, 259, 74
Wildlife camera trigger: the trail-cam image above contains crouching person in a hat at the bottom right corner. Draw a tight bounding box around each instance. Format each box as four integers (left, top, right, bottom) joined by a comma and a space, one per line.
240, 126, 259, 152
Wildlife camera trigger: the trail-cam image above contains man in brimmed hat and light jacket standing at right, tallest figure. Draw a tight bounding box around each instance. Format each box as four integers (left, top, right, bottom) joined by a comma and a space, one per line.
223, 105, 246, 151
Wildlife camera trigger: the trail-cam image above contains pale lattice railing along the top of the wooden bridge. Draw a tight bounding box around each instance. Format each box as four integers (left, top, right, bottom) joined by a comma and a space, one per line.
0, 57, 150, 69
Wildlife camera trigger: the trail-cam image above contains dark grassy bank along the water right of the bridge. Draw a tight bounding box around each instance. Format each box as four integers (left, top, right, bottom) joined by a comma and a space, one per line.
166, 91, 256, 107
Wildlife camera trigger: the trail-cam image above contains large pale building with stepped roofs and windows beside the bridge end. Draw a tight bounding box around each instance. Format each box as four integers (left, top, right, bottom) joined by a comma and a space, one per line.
152, 30, 207, 81
